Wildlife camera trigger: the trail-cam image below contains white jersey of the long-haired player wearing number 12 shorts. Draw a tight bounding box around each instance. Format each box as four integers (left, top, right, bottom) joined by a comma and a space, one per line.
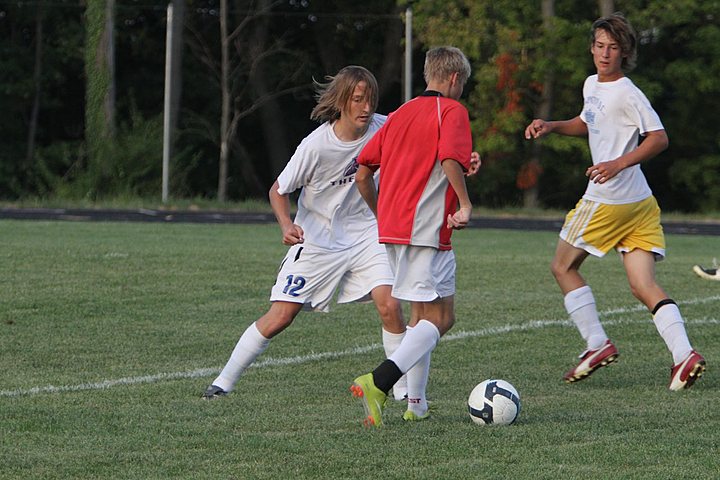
277, 114, 387, 250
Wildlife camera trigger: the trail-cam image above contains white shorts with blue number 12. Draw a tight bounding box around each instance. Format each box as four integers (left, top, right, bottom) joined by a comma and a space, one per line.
270, 235, 393, 312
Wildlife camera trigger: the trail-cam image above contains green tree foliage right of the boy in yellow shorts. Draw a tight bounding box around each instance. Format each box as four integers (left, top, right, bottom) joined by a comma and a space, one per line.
623, 0, 720, 212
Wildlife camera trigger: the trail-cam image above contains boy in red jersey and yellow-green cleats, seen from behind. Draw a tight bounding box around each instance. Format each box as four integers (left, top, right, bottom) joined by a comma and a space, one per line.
351, 47, 472, 427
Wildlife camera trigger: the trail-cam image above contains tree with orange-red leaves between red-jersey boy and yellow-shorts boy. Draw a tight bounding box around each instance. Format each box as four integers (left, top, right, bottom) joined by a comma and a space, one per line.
414, 0, 589, 207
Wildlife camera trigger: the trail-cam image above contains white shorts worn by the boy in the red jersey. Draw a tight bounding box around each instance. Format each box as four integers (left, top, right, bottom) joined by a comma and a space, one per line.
385, 243, 455, 302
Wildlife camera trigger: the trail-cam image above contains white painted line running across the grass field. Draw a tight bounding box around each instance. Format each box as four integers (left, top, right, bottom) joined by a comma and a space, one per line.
0, 295, 720, 397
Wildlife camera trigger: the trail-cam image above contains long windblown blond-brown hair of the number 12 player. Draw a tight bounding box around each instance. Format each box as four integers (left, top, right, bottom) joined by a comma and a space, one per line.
310, 65, 378, 122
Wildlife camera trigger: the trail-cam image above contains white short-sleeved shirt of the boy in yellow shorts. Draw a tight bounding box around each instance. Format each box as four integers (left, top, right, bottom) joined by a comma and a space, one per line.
580, 75, 664, 205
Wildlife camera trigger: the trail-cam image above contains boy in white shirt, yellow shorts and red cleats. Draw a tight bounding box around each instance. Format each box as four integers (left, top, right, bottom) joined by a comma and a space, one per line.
525, 14, 705, 390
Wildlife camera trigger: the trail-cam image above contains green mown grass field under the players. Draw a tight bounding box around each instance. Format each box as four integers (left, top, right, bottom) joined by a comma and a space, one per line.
0, 221, 720, 480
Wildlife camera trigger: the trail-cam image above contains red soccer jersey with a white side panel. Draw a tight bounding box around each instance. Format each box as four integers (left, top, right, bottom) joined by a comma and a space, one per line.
358, 92, 472, 250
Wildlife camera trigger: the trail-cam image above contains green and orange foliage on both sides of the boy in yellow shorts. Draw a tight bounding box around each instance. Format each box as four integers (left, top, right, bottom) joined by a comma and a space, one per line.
413, 0, 720, 210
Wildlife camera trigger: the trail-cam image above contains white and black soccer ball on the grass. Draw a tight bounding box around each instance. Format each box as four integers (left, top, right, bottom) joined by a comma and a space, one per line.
468, 380, 520, 425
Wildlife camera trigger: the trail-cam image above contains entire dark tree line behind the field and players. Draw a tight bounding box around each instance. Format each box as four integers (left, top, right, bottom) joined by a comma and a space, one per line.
0, 0, 720, 212
